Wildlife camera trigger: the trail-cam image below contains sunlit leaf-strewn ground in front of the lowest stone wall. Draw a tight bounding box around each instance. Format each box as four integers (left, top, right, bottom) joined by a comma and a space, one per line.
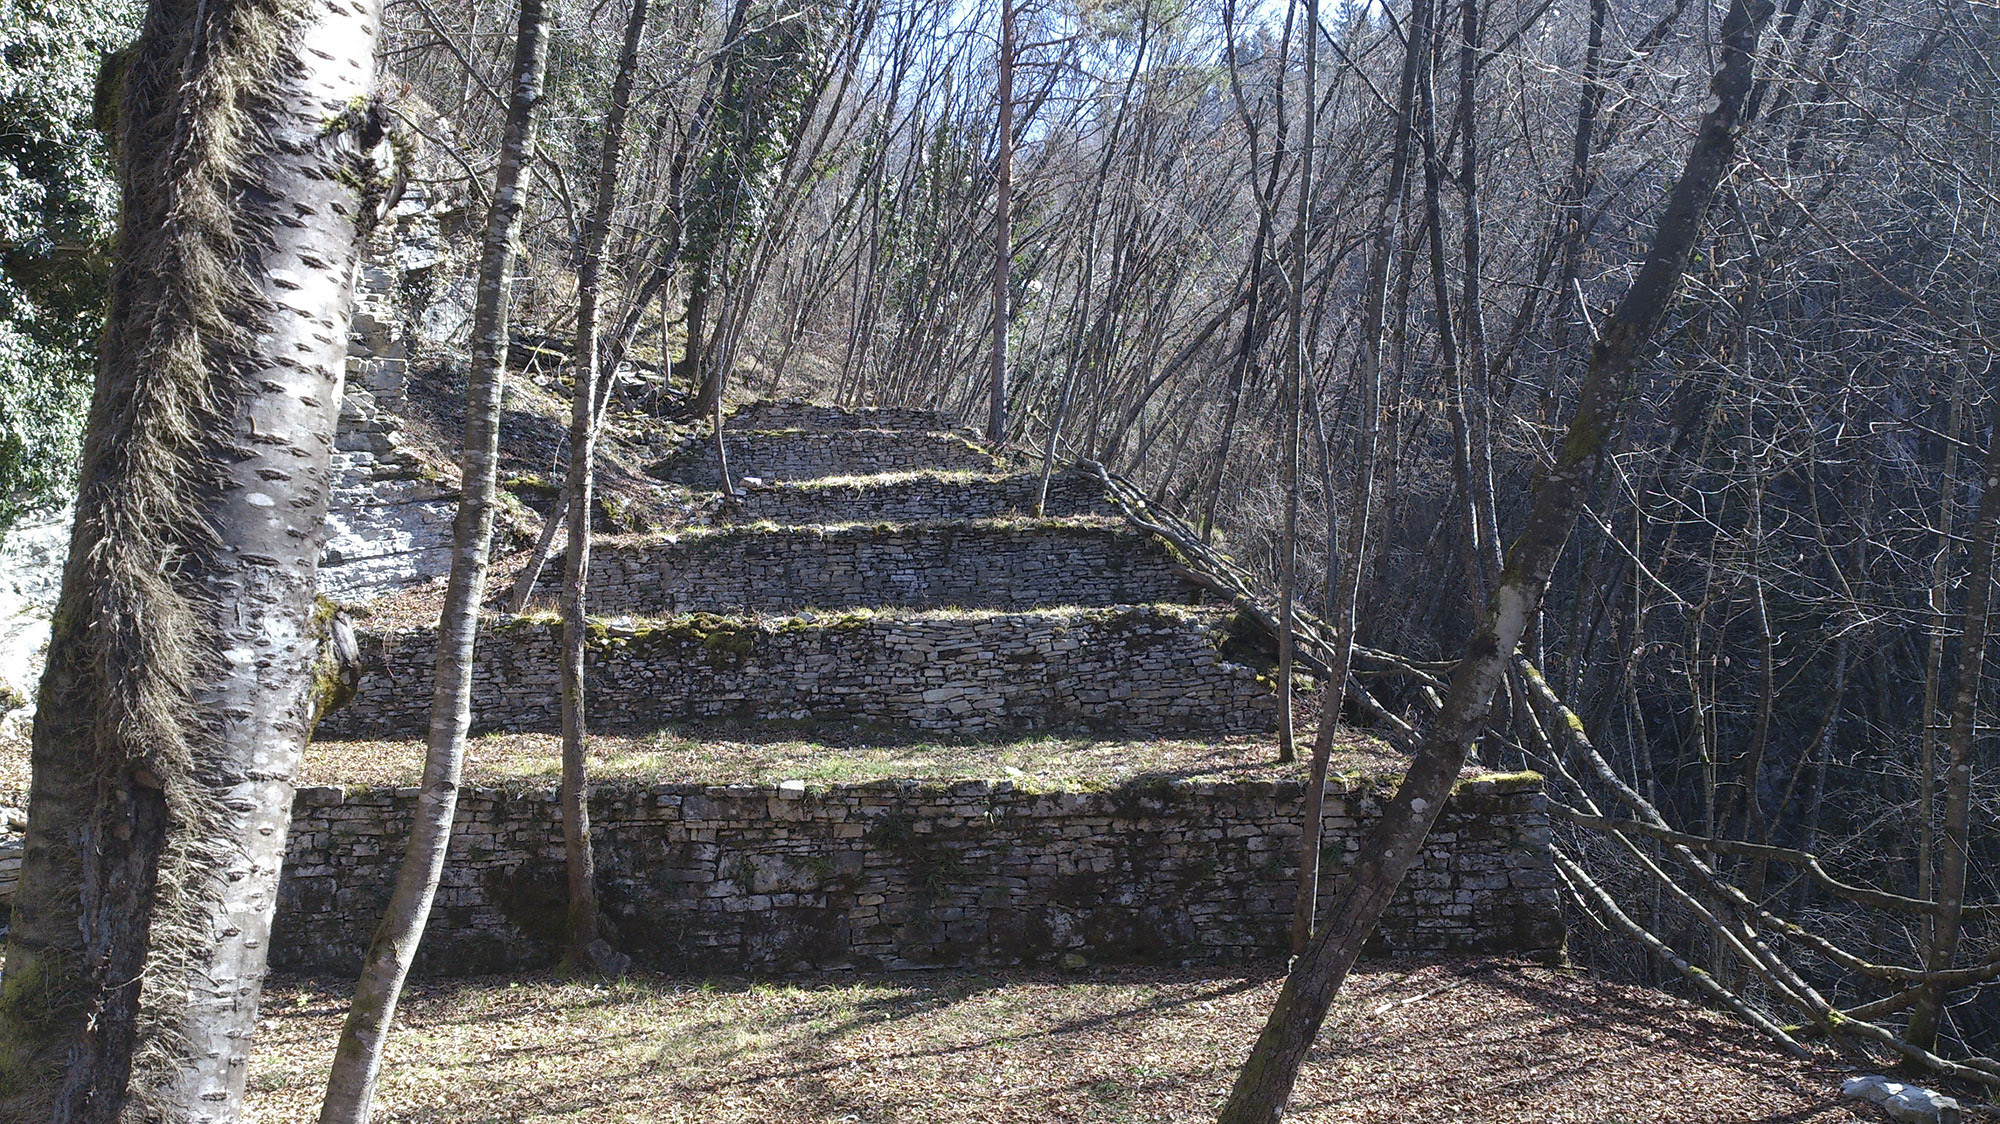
250, 960, 1920, 1124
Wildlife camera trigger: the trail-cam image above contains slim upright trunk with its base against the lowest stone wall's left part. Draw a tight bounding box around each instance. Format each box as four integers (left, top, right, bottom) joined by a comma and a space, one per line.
548, 0, 648, 970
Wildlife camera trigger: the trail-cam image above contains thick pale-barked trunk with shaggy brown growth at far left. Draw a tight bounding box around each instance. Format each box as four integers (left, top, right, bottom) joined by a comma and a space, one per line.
0, 0, 386, 1122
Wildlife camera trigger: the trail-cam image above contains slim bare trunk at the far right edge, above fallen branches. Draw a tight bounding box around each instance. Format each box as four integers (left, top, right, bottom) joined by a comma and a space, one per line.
1904, 392, 2000, 1050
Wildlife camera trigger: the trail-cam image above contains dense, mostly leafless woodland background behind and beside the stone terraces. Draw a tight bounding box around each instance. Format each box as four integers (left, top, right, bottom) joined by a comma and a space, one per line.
0, 0, 2000, 1054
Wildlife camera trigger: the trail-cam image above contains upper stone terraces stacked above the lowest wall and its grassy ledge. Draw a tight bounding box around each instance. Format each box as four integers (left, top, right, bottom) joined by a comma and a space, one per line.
322, 402, 1276, 738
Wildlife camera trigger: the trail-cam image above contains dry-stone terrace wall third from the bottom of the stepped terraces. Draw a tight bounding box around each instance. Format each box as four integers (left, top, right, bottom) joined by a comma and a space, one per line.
544, 520, 1198, 616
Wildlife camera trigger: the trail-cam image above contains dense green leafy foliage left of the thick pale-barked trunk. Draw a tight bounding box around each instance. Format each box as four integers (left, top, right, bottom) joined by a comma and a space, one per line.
0, 0, 138, 530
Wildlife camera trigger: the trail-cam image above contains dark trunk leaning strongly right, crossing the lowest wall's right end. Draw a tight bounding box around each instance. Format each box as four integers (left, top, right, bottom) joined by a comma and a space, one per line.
1220, 0, 1772, 1124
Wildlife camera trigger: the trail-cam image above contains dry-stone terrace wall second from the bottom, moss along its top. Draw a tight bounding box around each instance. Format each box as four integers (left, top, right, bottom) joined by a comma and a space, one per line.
320, 606, 1276, 738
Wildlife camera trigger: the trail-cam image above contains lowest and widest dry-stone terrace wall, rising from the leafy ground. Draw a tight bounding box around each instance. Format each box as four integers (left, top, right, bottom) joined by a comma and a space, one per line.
272, 776, 1562, 974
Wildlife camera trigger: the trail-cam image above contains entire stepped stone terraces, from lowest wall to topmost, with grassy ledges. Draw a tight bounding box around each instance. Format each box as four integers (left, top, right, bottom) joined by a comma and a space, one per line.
292, 402, 1562, 972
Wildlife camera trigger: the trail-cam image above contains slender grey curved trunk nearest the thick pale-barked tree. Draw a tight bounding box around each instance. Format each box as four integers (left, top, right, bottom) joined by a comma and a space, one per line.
320, 0, 548, 1124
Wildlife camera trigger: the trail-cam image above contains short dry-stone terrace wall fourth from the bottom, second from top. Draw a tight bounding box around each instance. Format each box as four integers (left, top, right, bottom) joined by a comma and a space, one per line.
722, 472, 1116, 526
